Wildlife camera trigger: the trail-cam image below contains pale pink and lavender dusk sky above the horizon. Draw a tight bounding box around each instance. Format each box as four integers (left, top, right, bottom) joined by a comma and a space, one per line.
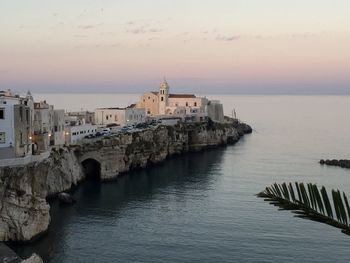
0, 0, 350, 94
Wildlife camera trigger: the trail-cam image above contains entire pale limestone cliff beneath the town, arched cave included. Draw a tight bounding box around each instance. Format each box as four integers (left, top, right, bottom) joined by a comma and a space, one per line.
0, 122, 252, 241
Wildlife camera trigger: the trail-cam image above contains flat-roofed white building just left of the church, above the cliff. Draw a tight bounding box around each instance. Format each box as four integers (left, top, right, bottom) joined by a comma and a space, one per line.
95, 105, 146, 126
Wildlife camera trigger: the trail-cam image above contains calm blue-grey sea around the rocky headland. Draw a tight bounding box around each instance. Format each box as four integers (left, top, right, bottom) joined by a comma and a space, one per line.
12, 94, 350, 263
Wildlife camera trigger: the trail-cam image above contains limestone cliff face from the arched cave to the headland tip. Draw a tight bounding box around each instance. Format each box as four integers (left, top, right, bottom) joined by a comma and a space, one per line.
74, 122, 251, 180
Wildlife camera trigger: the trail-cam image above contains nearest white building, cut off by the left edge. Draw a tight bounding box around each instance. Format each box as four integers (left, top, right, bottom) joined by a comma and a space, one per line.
0, 90, 32, 159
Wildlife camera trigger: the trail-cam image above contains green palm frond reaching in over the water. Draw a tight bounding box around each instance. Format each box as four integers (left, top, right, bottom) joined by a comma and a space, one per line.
257, 182, 350, 235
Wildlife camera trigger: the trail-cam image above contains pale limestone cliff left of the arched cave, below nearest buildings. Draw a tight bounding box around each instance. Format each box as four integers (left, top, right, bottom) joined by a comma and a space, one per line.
0, 150, 83, 241
